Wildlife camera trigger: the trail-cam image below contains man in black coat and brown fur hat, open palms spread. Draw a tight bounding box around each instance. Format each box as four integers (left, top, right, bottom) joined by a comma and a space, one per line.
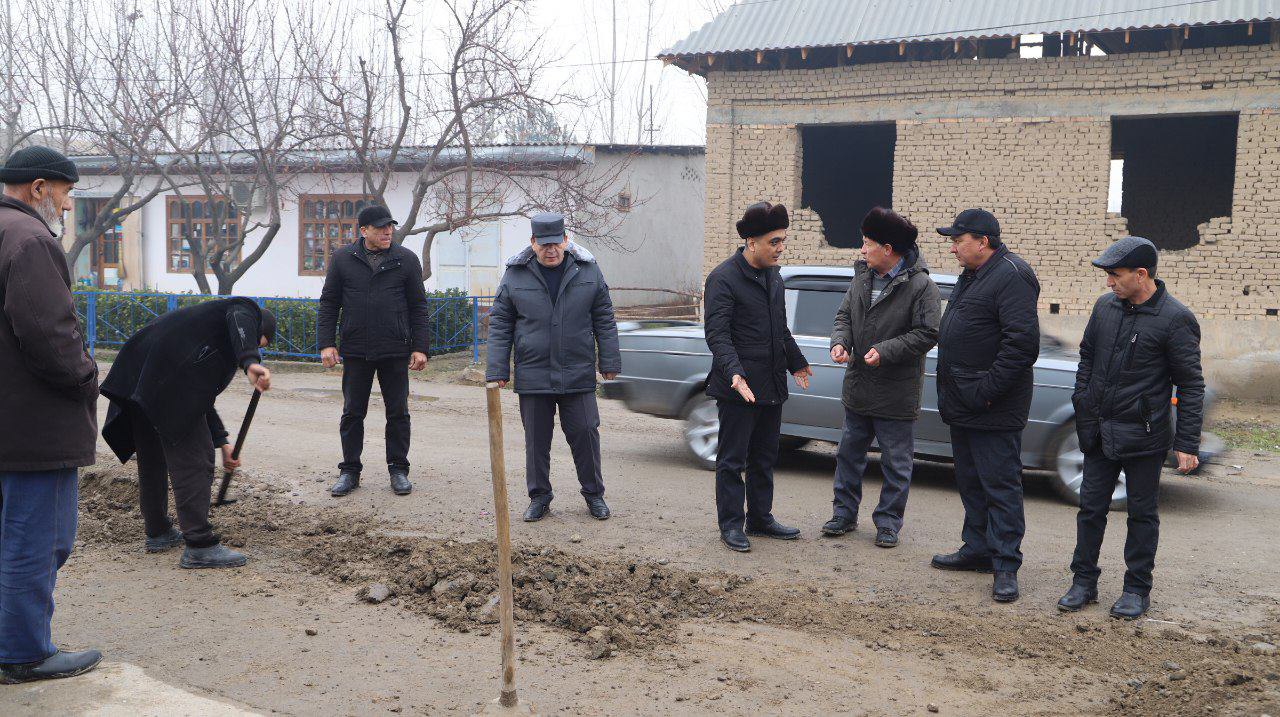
703, 201, 813, 553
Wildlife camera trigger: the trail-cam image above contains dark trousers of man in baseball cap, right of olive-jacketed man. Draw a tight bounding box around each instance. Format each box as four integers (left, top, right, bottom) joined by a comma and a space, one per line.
951, 426, 1027, 572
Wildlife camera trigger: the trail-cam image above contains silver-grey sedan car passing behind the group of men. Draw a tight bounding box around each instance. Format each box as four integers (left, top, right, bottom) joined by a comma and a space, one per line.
603, 266, 1222, 510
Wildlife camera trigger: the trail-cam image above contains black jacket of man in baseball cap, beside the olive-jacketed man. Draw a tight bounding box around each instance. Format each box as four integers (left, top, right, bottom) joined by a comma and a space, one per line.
937, 245, 1039, 430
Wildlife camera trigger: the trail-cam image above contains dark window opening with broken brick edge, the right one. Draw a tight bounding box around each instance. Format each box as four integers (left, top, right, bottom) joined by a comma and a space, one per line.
1111, 114, 1239, 250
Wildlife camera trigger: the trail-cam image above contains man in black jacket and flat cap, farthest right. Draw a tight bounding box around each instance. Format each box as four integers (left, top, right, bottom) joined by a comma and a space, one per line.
1057, 237, 1204, 620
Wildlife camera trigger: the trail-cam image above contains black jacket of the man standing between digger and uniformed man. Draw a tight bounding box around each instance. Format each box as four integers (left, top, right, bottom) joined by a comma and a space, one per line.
316, 239, 431, 361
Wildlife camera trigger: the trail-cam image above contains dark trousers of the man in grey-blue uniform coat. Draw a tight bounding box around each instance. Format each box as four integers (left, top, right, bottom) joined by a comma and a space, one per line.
520, 392, 604, 501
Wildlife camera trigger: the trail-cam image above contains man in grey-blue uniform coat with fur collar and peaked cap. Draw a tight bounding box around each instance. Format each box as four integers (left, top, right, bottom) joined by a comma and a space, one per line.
485, 213, 622, 522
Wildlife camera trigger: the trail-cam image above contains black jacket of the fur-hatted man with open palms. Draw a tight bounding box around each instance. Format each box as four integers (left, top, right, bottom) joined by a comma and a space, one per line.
703, 248, 809, 406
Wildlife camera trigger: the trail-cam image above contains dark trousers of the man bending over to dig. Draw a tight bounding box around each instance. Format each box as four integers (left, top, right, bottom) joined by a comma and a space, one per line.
128, 408, 219, 548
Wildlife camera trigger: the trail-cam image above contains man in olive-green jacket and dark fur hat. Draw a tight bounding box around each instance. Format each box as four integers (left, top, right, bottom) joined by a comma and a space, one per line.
822, 206, 942, 548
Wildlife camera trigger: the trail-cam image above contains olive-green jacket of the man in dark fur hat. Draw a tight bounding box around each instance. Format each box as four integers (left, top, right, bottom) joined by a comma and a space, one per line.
831, 252, 942, 421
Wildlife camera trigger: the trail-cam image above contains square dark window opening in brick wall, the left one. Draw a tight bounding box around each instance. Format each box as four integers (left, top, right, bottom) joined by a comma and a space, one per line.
800, 123, 897, 248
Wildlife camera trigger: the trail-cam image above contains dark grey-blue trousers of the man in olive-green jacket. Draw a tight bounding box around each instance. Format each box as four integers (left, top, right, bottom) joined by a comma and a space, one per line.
832, 408, 915, 533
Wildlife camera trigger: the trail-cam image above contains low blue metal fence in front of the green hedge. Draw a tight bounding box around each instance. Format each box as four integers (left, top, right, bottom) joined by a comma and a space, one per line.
74, 292, 493, 362
